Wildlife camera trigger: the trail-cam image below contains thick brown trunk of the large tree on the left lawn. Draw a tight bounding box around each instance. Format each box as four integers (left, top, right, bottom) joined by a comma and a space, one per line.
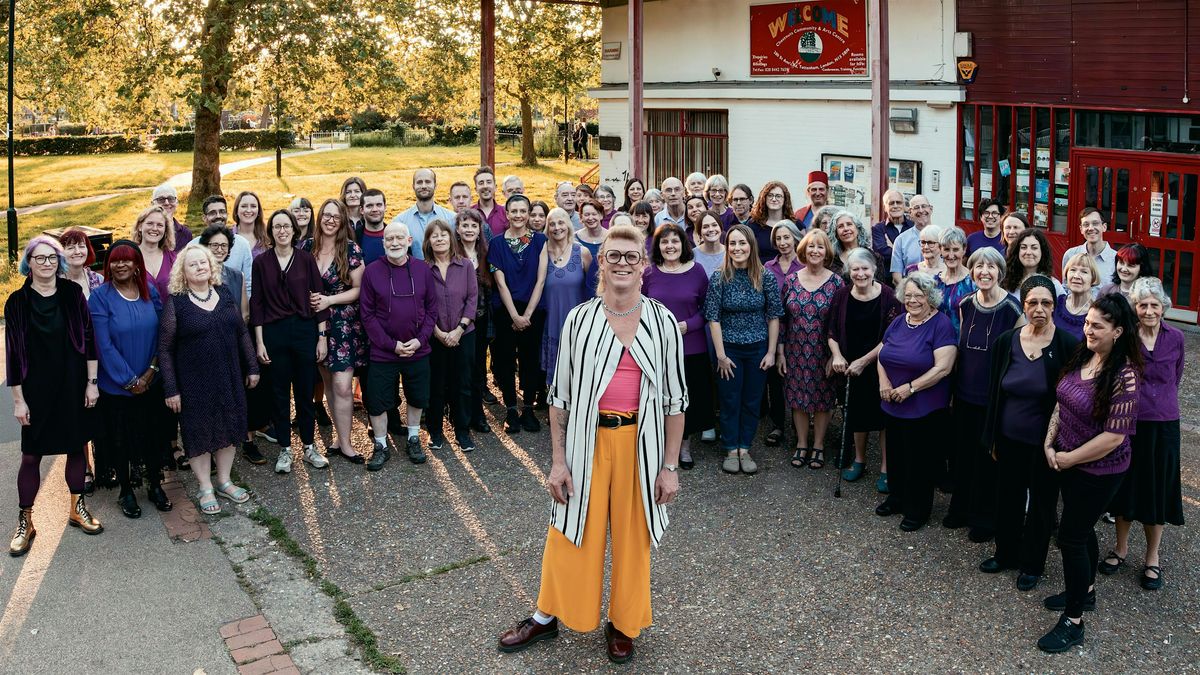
187, 0, 244, 221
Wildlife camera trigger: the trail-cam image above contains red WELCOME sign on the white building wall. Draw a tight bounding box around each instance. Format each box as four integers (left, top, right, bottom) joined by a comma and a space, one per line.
750, 0, 868, 77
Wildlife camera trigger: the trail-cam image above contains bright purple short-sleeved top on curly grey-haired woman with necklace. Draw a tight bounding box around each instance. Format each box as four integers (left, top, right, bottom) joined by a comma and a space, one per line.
880, 312, 958, 419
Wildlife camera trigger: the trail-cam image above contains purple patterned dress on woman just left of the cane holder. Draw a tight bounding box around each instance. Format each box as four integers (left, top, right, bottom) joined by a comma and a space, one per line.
782, 269, 845, 412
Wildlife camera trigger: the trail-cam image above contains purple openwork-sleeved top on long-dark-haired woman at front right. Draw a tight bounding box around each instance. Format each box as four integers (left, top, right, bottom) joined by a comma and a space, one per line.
1054, 365, 1139, 476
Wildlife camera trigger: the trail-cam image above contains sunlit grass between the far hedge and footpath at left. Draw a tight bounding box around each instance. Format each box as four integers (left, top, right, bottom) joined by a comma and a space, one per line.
0, 150, 270, 209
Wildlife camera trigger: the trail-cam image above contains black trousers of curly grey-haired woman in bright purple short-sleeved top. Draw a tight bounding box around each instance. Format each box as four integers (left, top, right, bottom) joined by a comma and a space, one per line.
884, 408, 949, 522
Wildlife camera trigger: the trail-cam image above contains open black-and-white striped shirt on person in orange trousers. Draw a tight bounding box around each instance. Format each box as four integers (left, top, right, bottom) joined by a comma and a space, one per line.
547, 297, 688, 546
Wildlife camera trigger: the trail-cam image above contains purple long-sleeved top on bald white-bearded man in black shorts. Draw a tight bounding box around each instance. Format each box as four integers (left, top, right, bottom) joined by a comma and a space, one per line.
359, 256, 438, 363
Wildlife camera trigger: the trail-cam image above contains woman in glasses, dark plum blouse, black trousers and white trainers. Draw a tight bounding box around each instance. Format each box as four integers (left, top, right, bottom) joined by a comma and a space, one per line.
250, 209, 329, 473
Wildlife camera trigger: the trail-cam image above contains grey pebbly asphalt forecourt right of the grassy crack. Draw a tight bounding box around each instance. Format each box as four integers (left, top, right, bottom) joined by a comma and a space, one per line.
239, 334, 1200, 673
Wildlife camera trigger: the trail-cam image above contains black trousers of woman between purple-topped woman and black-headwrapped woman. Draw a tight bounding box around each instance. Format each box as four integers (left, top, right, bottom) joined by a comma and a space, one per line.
946, 401, 996, 530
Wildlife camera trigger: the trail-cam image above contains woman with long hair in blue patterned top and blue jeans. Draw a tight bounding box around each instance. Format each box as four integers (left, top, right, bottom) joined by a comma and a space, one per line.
704, 225, 784, 474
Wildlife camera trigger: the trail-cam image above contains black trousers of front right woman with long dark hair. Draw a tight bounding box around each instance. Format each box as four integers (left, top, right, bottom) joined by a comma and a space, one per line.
1058, 467, 1124, 619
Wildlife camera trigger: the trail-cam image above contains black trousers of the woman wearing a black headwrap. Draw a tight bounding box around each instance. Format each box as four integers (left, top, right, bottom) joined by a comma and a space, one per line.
995, 434, 1058, 577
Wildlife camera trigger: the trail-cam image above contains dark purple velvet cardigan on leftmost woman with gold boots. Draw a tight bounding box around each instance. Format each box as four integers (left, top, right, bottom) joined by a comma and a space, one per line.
4, 277, 96, 387
